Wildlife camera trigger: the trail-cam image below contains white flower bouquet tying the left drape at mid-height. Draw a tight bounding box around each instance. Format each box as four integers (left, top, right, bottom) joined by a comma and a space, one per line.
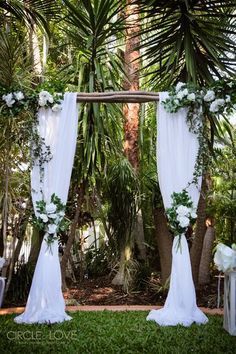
33, 194, 69, 246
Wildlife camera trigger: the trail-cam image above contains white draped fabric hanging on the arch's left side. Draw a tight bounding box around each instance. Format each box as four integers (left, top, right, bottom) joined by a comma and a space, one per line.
15, 93, 78, 323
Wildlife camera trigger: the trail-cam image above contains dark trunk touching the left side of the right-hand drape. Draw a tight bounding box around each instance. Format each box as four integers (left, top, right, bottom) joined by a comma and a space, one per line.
153, 208, 173, 284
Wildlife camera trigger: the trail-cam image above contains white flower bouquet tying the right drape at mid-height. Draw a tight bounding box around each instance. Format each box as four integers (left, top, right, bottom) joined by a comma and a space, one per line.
166, 189, 197, 248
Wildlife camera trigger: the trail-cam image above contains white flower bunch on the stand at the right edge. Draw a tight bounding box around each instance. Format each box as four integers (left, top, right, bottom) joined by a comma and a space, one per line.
214, 243, 236, 272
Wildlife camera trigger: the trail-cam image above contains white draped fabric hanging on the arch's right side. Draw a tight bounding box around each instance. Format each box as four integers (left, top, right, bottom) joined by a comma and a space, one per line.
147, 92, 208, 326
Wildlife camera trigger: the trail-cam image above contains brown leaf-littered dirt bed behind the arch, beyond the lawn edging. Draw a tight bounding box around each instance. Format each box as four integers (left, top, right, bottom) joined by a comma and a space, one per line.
64, 277, 223, 308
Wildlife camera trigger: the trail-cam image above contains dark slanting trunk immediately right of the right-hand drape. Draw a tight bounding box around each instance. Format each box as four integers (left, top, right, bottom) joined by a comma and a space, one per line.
190, 177, 207, 287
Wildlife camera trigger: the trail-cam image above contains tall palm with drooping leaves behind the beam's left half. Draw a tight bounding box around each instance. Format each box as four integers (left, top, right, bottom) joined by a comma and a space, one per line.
58, 0, 127, 283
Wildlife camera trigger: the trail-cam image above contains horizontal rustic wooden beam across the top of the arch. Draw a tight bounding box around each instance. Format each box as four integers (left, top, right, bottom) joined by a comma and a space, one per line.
77, 91, 159, 103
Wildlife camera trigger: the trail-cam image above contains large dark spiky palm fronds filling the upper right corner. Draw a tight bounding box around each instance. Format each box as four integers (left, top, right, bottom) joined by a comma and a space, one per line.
135, 0, 236, 90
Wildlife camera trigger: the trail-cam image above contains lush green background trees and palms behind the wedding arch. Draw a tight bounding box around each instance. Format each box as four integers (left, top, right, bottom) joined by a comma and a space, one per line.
0, 0, 235, 304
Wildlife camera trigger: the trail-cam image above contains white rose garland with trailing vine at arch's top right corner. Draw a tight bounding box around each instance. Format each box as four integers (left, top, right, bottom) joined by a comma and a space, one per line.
162, 80, 236, 184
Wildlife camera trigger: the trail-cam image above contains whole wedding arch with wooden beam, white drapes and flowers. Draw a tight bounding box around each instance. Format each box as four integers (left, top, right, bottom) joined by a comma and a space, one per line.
12, 83, 234, 326
